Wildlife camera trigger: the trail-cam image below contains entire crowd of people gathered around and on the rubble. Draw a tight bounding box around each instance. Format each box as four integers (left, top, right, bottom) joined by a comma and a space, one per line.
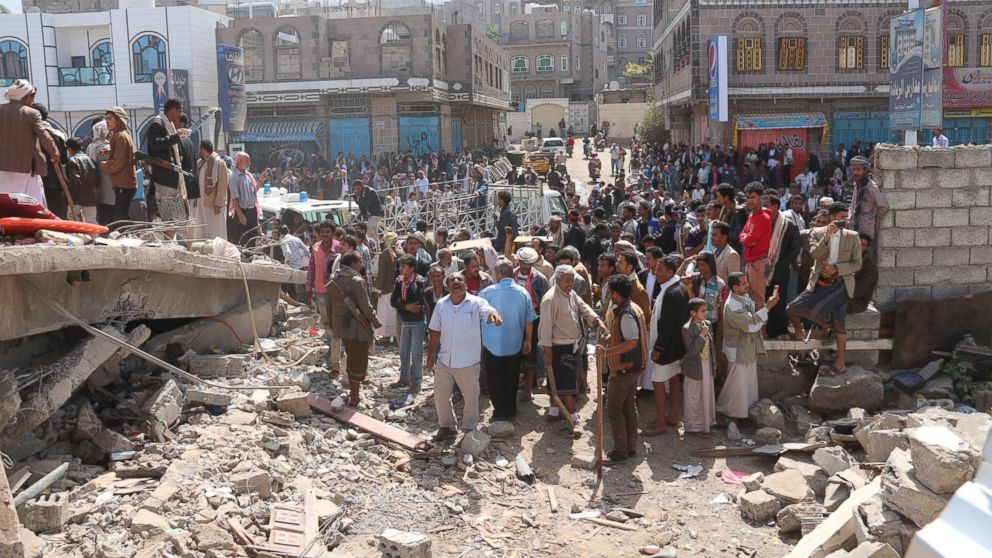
0, 80, 888, 463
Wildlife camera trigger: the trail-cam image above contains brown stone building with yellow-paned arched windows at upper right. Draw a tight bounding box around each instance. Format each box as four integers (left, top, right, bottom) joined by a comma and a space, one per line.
653, 0, 992, 158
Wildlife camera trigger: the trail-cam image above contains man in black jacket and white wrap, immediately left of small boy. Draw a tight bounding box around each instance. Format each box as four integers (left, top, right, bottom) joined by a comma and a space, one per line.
644, 256, 689, 436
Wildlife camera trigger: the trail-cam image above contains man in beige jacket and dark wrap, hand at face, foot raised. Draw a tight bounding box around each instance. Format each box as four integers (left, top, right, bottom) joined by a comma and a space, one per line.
787, 203, 861, 373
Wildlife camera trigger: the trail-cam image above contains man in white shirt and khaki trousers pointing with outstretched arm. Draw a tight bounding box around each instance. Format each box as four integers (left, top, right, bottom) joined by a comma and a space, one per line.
427, 273, 503, 442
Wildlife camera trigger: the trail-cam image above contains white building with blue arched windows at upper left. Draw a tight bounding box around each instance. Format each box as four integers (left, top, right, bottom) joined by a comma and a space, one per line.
0, 0, 227, 143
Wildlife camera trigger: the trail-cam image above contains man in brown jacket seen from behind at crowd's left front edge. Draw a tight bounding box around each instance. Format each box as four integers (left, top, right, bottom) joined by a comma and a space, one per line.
327, 252, 381, 407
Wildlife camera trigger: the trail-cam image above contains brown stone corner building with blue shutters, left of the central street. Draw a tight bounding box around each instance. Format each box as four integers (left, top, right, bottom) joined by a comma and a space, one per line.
217, 9, 510, 164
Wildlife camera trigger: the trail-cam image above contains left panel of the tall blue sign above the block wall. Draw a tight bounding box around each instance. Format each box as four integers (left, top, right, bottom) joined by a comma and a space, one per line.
889, 10, 924, 130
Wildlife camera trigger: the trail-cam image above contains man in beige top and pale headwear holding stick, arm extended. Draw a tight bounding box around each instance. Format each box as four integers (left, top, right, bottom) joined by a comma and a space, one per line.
538, 265, 608, 427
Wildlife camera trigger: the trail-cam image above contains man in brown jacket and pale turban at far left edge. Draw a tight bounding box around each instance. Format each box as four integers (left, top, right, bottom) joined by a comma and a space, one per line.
0, 79, 60, 204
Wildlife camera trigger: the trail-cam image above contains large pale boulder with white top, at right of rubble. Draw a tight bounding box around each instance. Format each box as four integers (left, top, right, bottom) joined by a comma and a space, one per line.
909, 426, 981, 494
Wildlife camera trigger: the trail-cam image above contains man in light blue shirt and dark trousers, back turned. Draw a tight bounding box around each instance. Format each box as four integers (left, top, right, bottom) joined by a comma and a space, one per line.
479, 260, 537, 421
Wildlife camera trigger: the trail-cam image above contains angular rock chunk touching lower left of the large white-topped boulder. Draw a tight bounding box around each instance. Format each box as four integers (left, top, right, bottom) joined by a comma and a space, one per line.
882, 449, 948, 527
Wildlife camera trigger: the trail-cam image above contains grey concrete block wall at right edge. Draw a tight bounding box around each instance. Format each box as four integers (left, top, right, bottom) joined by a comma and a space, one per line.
875, 145, 992, 309
